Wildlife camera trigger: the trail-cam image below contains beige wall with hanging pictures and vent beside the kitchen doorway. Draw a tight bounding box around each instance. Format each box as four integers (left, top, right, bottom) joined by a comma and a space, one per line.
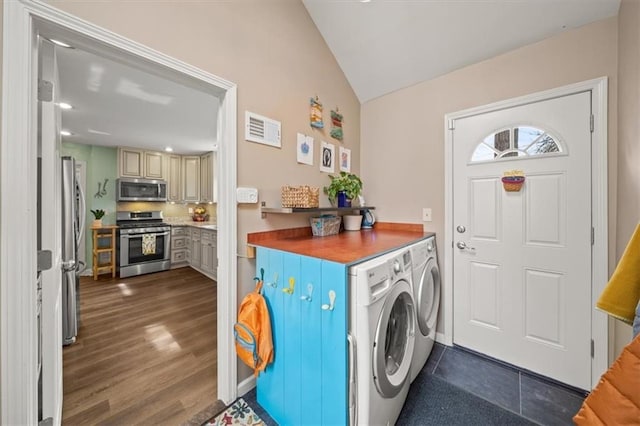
36, 0, 360, 380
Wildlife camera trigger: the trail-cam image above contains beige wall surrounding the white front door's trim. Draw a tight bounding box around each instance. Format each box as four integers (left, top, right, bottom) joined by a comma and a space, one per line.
361, 18, 618, 342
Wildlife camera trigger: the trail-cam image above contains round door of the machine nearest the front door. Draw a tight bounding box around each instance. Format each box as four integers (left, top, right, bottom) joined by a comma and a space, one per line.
416, 257, 440, 336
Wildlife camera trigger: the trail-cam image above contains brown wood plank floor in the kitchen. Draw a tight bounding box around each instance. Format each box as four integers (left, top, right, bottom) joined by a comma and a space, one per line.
62, 268, 219, 425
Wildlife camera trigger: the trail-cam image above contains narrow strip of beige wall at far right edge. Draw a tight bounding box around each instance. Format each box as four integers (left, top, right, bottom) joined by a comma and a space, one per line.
611, 0, 640, 354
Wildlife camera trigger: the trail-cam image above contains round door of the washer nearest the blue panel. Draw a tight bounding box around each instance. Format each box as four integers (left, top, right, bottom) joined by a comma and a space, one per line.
372, 280, 415, 398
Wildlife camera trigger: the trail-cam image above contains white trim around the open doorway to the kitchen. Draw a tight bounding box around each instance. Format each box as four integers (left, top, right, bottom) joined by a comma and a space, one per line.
0, 0, 237, 424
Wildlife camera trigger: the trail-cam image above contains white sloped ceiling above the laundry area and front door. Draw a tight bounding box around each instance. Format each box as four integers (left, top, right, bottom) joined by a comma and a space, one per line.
302, 0, 620, 103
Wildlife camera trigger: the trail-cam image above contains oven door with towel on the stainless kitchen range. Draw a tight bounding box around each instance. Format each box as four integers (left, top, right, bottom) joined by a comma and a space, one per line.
120, 231, 171, 267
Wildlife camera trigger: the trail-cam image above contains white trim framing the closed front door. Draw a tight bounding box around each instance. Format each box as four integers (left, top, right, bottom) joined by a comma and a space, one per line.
440, 77, 609, 386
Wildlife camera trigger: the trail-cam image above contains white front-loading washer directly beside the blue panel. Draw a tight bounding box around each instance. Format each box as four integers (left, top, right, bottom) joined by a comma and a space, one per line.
349, 248, 415, 425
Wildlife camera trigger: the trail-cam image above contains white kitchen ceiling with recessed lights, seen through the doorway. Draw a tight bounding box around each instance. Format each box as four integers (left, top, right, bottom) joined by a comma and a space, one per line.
56, 47, 219, 154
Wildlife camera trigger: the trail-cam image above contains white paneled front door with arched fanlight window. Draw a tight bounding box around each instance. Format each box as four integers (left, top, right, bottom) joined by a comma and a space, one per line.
453, 91, 592, 389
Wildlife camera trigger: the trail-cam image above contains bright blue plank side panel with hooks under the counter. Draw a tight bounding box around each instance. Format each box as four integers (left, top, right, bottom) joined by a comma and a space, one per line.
256, 247, 349, 425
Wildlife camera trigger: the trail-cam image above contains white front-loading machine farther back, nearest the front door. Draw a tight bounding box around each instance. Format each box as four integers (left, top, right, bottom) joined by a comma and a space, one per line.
409, 237, 440, 382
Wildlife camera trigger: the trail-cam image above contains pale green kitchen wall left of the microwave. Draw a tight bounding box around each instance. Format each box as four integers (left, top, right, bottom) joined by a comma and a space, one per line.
60, 143, 118, 269
